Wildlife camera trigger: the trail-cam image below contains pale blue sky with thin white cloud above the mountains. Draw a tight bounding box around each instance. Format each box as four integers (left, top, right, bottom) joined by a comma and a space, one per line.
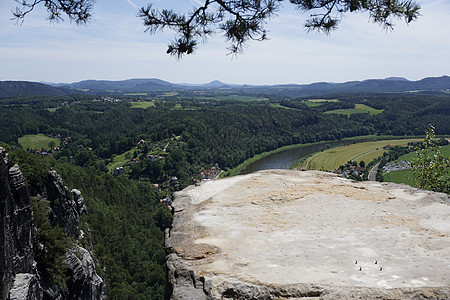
0, 0, 450, 84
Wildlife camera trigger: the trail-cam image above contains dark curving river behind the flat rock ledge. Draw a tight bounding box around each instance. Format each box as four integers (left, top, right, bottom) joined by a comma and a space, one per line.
240, 139, 368, 175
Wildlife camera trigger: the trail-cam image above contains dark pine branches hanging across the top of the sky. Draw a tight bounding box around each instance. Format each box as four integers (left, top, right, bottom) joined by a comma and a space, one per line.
14, 0, 420, 57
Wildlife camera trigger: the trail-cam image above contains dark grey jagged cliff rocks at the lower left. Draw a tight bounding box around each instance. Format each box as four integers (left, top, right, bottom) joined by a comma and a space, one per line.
0, 147, 106, 300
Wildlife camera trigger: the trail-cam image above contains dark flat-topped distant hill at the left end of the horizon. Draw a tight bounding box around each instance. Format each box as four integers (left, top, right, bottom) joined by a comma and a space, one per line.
0, 81, 74, 99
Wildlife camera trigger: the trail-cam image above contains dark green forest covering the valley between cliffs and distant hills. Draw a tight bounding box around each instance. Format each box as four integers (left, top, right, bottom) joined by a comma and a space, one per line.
0, 91, 450, 299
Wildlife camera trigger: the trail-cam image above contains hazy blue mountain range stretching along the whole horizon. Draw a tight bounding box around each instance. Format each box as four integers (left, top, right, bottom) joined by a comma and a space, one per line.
0, 76, 450, 98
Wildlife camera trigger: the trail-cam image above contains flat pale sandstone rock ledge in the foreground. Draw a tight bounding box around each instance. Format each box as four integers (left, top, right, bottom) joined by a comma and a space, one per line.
166, 170, 450, 299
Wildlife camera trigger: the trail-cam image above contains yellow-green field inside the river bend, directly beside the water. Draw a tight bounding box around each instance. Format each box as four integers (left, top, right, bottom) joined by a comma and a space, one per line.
297, 139, 421, 170
